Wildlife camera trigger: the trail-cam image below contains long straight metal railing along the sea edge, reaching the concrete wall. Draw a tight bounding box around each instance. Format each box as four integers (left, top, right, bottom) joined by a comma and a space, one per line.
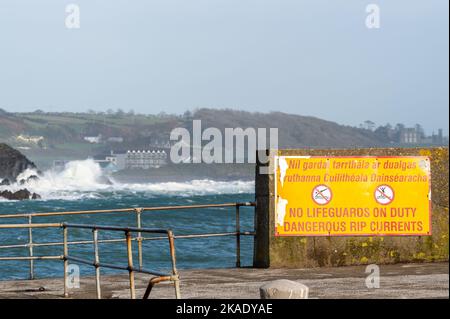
0, 202, 255, 298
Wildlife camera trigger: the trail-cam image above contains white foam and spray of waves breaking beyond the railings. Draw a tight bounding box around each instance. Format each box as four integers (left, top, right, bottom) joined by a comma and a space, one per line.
0, 160, 254, 200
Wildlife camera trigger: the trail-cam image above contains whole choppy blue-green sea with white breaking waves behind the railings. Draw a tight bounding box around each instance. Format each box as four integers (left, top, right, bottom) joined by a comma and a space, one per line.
0, 160, 254, 280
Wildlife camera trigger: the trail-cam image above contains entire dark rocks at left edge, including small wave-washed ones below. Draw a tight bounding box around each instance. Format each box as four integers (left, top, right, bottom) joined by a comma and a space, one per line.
0, 144, 41, 200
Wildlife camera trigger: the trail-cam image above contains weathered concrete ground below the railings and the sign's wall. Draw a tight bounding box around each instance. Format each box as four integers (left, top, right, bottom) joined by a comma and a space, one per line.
0, 263, 449, 299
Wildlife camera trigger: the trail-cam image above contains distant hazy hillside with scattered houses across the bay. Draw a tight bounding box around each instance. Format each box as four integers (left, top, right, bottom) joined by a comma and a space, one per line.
0, 109, 392, 169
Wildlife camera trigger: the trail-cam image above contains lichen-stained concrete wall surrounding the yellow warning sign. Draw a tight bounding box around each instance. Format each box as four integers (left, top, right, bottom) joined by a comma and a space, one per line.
254, 148, 449, 268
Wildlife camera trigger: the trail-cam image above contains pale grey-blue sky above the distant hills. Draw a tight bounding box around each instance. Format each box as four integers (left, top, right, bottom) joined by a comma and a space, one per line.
0, 0, 449, 133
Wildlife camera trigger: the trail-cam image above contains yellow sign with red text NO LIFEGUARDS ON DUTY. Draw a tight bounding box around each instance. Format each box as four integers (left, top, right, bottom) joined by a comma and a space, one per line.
274, 156, 431, 236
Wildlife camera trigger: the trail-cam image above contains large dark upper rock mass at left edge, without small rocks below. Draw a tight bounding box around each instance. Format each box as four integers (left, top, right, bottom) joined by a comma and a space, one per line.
0, 144, 36, 183
